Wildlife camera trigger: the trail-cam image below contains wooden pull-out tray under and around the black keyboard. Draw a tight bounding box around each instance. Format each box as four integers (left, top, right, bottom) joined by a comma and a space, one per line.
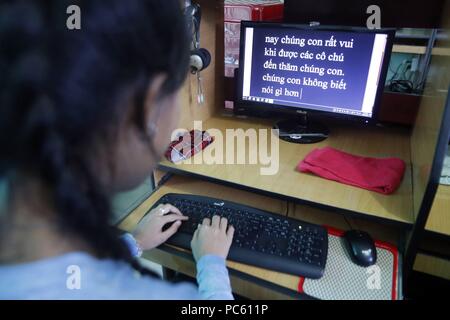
119, 175, 398, 299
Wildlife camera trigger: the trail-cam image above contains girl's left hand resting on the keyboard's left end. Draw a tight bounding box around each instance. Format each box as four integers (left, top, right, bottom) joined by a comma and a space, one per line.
133, 204, 188, 251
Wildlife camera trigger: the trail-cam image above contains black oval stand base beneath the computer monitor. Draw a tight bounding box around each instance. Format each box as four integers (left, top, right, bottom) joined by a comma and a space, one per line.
274, 115, 330, 144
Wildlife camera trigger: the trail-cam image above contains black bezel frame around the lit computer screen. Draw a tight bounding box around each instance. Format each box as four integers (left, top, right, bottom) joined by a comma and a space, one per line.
234, 21, 396, 124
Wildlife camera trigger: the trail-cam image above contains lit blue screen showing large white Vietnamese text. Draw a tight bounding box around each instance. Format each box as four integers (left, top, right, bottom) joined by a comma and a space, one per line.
241, 25, 388, 118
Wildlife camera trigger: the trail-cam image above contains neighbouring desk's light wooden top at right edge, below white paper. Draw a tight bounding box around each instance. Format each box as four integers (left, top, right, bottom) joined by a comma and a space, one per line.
425, 184, 450, 236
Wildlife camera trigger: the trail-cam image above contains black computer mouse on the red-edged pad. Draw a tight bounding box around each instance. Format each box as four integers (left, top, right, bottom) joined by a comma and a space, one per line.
344, 230, 377, 267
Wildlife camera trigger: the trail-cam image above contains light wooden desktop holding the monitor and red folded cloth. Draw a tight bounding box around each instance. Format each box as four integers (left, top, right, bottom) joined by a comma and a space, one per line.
160, 117, 413, 225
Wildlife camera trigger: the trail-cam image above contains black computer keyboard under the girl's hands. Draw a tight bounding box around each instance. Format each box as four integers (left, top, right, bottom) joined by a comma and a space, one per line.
149, 194, 328, 279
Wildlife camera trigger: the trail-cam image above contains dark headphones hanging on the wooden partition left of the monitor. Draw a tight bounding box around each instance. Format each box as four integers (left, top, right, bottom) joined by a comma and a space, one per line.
185, 1, 211, 74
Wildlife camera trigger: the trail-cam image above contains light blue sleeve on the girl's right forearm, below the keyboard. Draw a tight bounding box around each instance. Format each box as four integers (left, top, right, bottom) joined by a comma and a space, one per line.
197, 255, 234, 300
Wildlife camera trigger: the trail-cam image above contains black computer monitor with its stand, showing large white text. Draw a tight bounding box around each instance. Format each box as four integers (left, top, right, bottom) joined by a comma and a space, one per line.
235, 22, 395, 143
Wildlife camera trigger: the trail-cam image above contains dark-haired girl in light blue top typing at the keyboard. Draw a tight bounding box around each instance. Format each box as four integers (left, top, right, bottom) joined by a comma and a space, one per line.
0, 0, 234, 299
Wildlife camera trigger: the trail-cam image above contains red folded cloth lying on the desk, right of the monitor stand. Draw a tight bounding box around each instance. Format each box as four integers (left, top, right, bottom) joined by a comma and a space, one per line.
297, 147, 405, 194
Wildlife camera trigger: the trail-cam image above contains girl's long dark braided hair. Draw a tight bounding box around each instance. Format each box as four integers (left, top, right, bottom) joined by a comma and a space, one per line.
0, 0, 189, 272
